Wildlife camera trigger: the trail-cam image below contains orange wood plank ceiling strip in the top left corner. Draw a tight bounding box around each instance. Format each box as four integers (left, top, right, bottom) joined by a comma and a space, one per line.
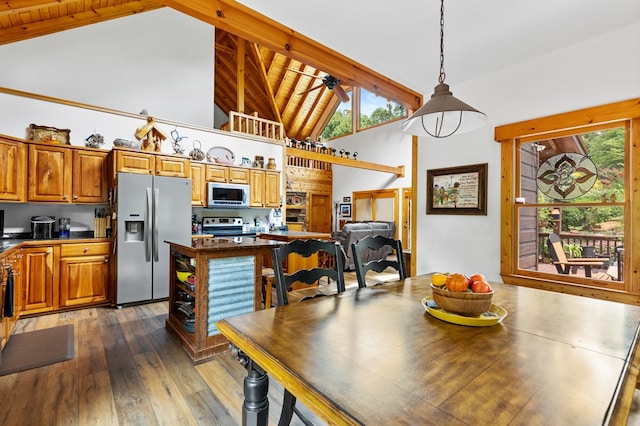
0, 0, 164, 45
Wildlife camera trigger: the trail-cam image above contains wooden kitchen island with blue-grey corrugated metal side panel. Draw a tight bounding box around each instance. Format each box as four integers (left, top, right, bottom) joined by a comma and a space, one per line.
166, 237, 282, 362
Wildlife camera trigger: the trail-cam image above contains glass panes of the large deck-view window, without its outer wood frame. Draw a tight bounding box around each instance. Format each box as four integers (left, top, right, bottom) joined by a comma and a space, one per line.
515, 123, 628, 287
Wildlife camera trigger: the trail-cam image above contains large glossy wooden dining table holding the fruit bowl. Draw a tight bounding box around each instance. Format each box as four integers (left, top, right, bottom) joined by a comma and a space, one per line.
216, 274, 640, 425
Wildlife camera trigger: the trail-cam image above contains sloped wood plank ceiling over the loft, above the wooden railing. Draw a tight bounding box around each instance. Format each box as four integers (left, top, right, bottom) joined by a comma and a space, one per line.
214, 30, 350, 140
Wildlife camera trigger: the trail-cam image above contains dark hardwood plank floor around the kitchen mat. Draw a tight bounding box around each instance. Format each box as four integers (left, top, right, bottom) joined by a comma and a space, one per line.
0, 302, 322, 426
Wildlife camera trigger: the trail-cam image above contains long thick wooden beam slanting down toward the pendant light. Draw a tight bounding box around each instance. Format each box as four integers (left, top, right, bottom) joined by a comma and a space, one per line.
155, 0, 422, 110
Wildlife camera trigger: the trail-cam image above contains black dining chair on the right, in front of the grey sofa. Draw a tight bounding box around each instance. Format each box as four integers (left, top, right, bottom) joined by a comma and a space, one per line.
351, 235, 407, 288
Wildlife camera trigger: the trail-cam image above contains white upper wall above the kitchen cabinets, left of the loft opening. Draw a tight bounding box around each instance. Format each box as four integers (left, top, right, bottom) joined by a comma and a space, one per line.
0, 8, 214, 126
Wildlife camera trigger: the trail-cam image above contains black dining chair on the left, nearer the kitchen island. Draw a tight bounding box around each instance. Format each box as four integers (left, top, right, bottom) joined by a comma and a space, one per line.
273, 239, 345, 426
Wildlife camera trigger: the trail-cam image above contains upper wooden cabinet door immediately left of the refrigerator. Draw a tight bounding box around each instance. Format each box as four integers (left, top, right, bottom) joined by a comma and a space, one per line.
72, 149, 108, 203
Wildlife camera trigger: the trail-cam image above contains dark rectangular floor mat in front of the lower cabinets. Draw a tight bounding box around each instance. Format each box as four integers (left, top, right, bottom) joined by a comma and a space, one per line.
0, 324, 73, 376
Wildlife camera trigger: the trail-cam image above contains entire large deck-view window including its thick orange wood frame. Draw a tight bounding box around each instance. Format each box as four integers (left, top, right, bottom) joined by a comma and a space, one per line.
495, 99, 640, 303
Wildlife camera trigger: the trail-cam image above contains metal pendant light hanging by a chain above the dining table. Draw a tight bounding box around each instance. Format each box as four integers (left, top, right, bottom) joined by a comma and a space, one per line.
400, 0, 487, 139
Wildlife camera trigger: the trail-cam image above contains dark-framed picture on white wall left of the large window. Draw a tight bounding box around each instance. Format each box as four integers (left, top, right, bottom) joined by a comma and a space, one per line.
427, 163, 488, 215
